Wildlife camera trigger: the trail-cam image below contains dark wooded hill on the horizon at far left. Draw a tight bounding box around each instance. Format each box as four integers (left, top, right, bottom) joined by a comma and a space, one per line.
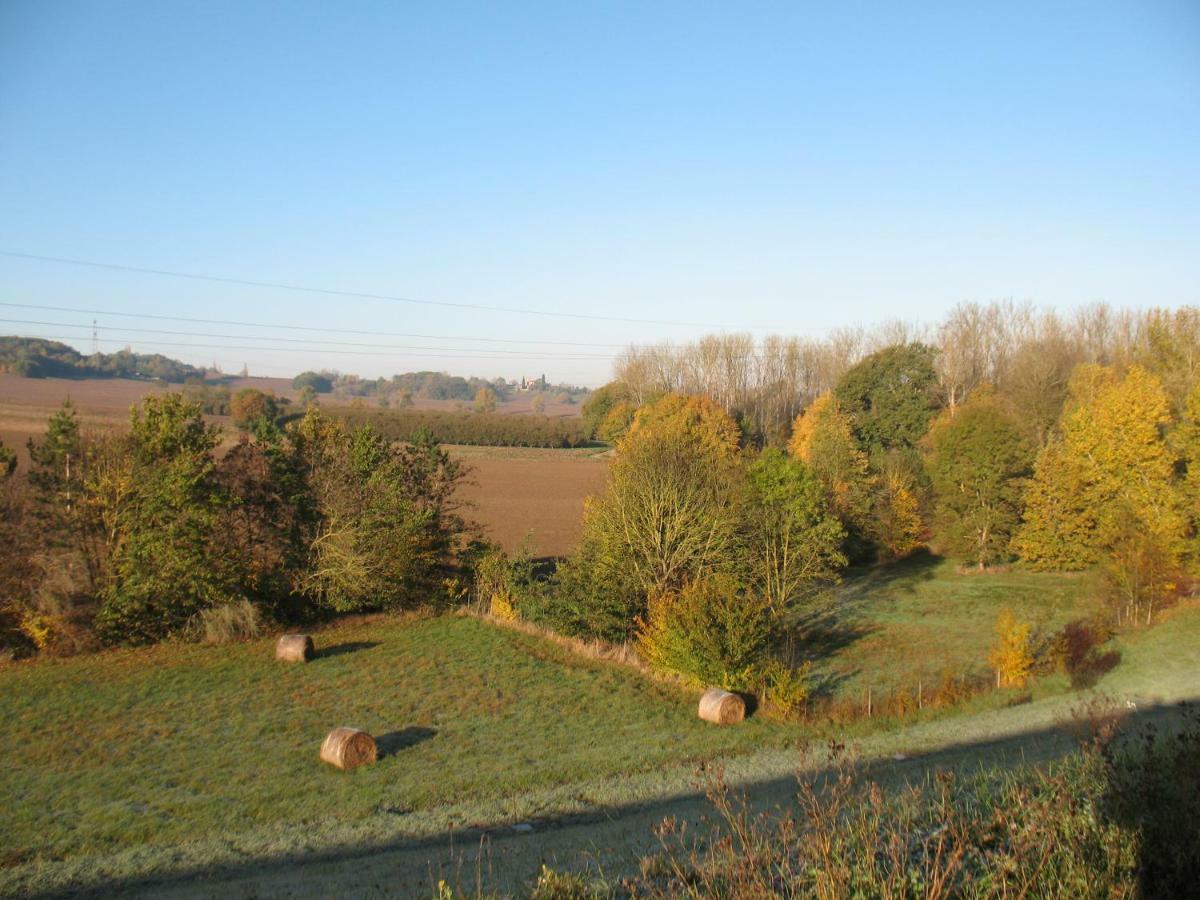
0, 336, 204, 383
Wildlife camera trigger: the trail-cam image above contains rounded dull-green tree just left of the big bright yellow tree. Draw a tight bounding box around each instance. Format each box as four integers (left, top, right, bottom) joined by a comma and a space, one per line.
926, 391, 1033, 569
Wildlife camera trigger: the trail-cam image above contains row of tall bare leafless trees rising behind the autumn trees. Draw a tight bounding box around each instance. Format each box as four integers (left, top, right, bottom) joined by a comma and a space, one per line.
598, 302, 1200, 446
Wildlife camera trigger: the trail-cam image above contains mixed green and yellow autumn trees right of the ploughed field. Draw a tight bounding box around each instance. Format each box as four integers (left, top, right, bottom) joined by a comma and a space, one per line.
476, 306, 1200, 708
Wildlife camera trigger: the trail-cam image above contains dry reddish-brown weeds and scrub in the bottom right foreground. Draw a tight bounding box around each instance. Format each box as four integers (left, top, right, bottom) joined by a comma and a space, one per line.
609, 715, 1200, 898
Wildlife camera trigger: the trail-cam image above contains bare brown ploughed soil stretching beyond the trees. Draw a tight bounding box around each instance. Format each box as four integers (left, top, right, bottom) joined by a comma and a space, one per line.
0, 374, 608, 556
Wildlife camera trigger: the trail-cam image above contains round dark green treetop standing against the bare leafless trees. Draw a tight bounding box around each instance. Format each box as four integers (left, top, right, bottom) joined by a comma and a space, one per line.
834, 343, 937, 455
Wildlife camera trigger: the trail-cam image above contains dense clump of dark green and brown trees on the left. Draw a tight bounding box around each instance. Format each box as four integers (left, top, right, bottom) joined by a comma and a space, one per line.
0, 392, 467, 652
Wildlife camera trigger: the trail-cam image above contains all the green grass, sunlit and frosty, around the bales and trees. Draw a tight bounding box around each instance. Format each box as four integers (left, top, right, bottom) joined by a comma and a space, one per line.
0, 559, 1200, 895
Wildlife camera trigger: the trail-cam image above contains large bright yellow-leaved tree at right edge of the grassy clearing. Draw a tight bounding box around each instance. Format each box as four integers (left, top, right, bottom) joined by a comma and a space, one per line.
1014, 365, 1186, 569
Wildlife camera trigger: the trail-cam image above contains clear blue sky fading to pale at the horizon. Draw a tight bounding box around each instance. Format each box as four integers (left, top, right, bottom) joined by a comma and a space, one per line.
0, 0, 1200, 384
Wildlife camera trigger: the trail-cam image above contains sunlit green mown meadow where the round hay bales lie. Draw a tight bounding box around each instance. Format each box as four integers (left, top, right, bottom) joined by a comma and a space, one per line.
0, 617, 785, 862
